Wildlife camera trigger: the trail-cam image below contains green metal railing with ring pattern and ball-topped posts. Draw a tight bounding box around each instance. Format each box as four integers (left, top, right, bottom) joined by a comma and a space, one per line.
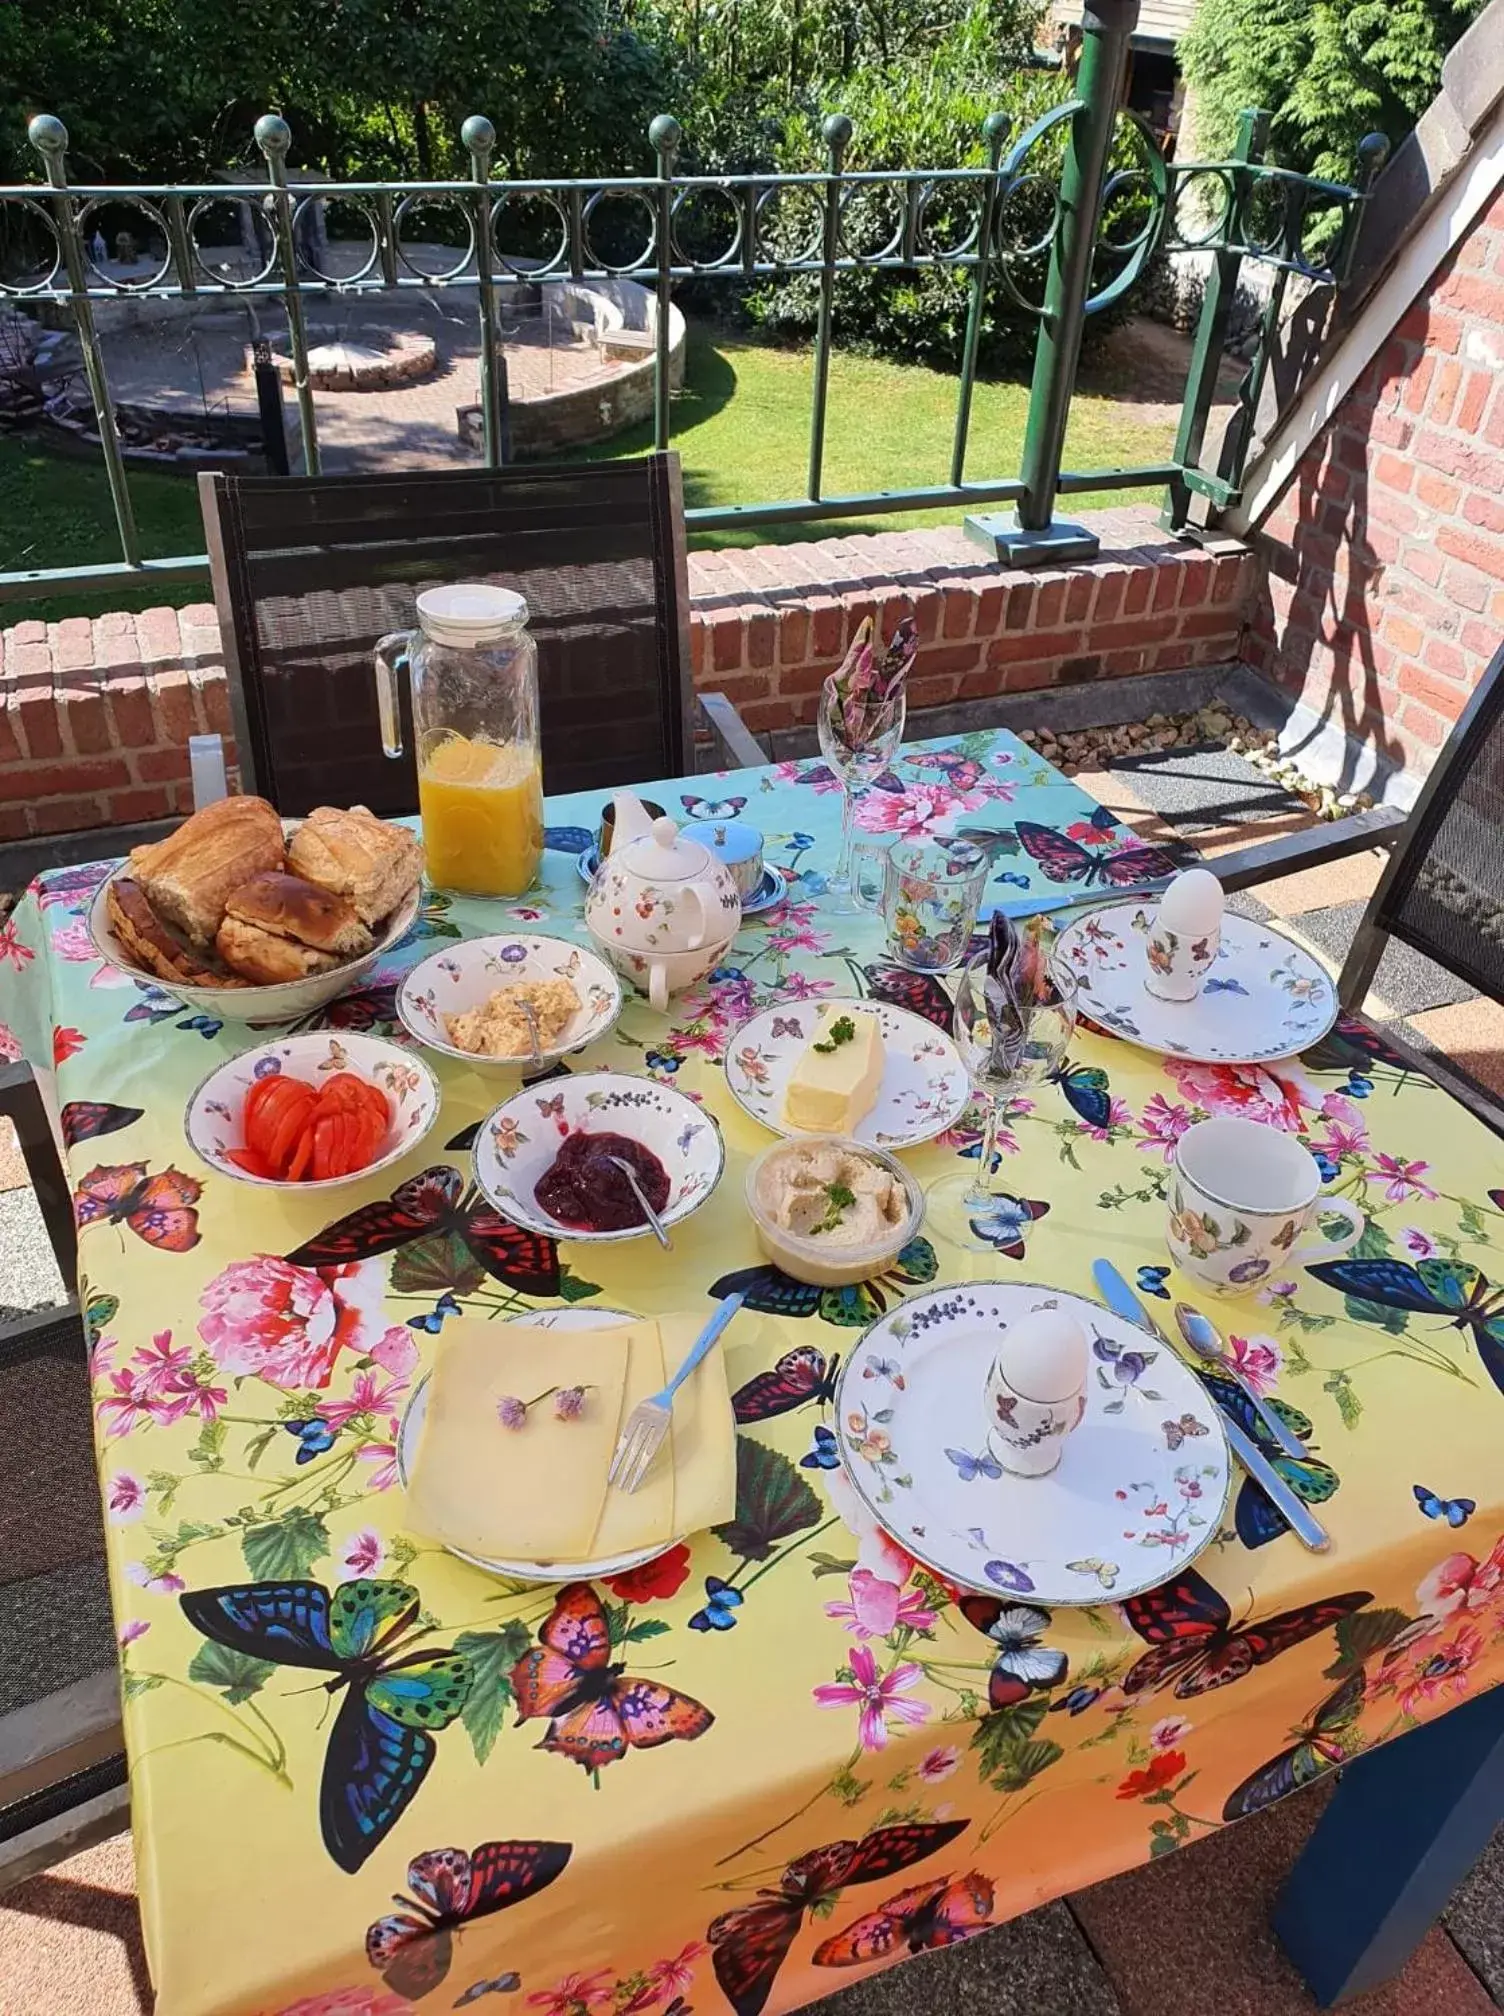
0, 0, 1387, 601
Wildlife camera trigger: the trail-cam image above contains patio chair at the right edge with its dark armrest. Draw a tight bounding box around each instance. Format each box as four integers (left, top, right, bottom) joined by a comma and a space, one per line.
1212, 645, 1504, 1131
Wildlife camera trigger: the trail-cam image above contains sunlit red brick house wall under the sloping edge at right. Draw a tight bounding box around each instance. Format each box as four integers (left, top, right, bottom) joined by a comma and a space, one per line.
1242, 196, 1504, 770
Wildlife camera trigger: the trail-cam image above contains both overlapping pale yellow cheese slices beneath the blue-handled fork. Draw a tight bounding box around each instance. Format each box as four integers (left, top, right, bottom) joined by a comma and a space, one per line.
407, 1314, 736, 1564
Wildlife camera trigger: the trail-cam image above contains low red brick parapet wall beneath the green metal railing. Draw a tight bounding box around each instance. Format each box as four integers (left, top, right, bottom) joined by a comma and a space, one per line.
0, 508, 1256, 841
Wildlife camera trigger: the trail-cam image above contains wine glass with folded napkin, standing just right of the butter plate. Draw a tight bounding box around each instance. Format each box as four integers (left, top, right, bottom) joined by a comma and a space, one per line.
929, 954, 1077, 1250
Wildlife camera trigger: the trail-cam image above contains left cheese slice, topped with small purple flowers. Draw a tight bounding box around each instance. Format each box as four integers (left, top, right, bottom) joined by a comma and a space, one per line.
407, 1318, 629, 1560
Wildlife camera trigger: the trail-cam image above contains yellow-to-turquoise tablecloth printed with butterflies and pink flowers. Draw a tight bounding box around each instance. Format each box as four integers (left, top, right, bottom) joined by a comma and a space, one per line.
0, 734, 1504, 2016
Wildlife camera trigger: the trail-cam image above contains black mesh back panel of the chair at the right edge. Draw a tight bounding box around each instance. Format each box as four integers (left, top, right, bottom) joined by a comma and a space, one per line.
1355, 645, 1504, 1000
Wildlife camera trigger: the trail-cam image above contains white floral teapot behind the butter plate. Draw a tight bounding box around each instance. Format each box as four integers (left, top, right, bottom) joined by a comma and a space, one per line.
585, 790, 742, 1014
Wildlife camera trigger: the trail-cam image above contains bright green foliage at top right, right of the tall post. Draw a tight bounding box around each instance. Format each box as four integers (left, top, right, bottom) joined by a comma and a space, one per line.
1179, 0, 1482, 181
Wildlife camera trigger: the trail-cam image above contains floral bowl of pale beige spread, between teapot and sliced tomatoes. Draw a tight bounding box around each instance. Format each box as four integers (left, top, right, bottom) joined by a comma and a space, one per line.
397, 931, 621, 1070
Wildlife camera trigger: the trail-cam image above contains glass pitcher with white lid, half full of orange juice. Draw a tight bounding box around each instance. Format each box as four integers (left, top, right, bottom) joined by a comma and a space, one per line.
375, 583, 542, 895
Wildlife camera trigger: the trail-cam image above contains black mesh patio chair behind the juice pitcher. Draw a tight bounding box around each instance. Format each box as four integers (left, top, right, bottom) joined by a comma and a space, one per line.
200, 454, 766, 814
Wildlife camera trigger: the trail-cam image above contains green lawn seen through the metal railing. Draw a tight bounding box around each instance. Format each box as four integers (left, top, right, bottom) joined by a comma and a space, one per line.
0, 327, 1173, 621
